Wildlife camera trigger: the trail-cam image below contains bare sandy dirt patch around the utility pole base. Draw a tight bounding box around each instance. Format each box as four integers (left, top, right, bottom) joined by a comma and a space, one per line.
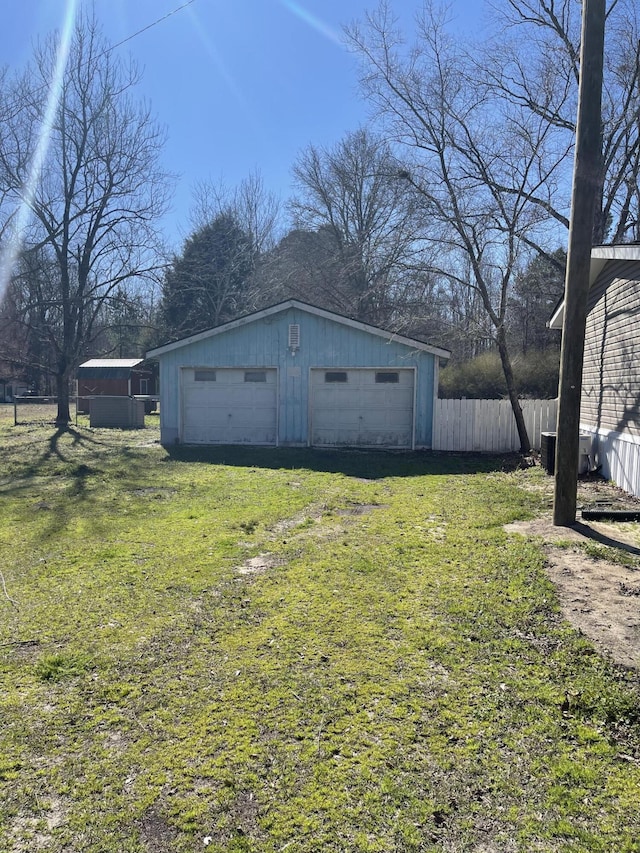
505, 477, 640, 668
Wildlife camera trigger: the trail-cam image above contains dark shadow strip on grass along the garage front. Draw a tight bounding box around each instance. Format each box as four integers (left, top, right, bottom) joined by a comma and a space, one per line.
164, 445, 522, 480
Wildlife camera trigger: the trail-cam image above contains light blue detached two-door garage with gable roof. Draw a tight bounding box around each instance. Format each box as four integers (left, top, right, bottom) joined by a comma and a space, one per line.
147, 299, 449, 450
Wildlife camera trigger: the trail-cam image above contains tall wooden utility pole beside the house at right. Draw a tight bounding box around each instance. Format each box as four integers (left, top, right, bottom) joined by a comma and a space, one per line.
553, 0, 605, 527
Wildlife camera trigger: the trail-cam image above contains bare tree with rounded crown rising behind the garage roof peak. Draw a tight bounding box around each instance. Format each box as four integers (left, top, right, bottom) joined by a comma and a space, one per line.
291, 129, 419, 324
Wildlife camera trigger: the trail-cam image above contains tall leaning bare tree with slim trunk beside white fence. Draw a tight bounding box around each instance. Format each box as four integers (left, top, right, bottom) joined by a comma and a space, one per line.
351, 3, 548, 453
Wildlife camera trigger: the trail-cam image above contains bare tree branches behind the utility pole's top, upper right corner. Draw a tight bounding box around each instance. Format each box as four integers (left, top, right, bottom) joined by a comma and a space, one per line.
484, 0, 640, 244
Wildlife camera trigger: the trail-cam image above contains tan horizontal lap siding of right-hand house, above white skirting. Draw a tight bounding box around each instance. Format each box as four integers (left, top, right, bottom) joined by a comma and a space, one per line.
580, 261, 640, 436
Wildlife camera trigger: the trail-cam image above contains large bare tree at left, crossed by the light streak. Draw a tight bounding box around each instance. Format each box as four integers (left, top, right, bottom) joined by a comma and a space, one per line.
0, 11, 170, 424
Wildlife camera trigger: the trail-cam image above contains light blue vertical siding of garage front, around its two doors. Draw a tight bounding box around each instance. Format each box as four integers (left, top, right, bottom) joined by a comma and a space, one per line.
160, 308, 436, 447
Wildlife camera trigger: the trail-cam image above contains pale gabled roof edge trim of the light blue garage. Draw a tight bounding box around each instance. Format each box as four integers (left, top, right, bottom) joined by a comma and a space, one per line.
146, 299, 451, 358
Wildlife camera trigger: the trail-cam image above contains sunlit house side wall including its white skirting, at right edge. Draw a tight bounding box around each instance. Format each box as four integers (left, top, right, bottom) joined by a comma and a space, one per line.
580, 261, 640, 495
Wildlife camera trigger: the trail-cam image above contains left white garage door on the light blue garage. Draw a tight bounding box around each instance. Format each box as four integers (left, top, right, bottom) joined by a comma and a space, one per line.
182, 368, 278, 444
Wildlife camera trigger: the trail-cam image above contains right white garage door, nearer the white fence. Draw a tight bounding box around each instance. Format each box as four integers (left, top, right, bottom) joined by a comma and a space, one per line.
311, 368, 414, 448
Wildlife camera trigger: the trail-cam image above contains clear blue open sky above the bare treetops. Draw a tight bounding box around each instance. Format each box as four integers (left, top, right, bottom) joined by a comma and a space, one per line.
0, 0, 481, 248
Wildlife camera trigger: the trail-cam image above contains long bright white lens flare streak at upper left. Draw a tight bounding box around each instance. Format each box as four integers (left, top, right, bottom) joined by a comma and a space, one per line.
0, 0, 79, 302
